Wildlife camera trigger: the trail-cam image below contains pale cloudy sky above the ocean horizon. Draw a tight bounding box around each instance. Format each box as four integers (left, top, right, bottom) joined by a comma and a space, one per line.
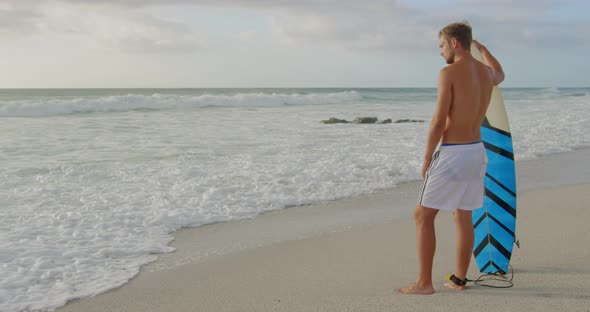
0, 0, 590, 88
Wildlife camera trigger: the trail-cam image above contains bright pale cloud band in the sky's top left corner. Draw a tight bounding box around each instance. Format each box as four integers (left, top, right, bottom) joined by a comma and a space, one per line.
0, 1, 206, 53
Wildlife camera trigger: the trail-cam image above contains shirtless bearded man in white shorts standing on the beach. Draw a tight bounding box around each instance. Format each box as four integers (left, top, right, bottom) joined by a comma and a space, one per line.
399, 23, 504, 294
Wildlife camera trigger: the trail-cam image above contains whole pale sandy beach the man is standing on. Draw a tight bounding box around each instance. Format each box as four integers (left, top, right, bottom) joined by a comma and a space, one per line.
52, 151, 590, 312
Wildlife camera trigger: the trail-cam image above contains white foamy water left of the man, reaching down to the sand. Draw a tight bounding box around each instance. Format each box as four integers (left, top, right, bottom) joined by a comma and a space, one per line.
0, 100, 424, 311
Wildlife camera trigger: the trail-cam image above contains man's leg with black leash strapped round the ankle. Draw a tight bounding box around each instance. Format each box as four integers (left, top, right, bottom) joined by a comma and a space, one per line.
445, 209, 474, 290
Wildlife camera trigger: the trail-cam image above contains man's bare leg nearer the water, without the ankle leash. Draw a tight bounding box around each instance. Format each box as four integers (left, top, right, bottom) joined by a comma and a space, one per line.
399, 205, 438, 295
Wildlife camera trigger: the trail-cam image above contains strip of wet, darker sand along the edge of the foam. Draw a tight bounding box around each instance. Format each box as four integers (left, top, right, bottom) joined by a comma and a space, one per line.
139, 148, 590, 274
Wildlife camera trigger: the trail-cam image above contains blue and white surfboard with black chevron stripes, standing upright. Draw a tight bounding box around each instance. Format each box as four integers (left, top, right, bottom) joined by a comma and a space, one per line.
471, 46, 516, 274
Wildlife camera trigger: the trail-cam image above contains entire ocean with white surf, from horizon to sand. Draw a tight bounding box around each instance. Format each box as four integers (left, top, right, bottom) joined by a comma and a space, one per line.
0, 88, 590, 311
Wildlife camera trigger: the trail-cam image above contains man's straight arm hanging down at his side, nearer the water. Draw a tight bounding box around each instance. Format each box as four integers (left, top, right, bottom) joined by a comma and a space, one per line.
422, 68, 453, 178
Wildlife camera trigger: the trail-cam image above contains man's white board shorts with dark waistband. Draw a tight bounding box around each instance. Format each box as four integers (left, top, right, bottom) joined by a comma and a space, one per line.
419, 142, 488, 210
